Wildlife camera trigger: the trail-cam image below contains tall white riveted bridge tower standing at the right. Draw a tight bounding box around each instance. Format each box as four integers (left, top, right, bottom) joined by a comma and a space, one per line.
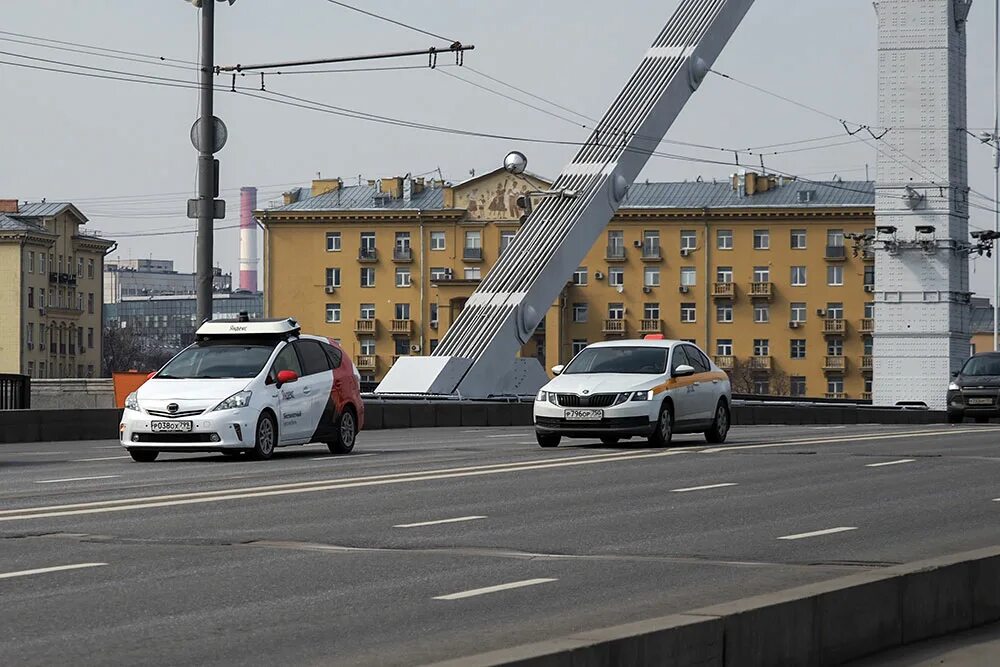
873, 0, 972, 409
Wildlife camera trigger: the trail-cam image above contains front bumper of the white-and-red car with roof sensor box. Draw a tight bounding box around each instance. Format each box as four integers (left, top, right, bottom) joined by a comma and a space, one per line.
119, 408, 260, 451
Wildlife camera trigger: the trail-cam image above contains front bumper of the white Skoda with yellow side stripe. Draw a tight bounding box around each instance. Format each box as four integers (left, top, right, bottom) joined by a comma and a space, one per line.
534, 401, 659, 438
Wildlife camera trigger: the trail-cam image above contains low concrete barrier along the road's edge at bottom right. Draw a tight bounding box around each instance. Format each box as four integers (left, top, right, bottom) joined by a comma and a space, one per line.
426, 547, 1000, 667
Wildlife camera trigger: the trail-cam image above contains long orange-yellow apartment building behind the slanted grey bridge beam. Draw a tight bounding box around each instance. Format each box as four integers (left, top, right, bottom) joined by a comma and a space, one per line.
256, 170, 875, 399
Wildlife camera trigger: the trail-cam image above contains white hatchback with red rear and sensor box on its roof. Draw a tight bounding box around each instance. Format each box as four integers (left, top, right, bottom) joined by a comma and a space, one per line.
119, 313, 365, 462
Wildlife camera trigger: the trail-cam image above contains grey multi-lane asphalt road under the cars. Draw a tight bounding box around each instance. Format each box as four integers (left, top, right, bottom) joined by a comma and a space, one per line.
0, 424, 1000, 665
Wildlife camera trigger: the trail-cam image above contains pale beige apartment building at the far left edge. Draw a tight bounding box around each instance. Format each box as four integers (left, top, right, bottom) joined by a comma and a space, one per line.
0, 200, 113, 378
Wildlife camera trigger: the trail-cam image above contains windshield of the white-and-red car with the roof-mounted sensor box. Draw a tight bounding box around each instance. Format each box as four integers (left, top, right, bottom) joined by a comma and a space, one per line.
156, 340, 276, 380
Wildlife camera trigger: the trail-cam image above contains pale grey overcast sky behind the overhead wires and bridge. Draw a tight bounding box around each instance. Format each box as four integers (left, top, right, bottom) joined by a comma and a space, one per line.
0, 0, 993, 294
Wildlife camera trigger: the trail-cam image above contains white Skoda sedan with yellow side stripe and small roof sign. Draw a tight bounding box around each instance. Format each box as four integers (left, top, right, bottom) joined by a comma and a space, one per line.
534, 338, 732, 447
